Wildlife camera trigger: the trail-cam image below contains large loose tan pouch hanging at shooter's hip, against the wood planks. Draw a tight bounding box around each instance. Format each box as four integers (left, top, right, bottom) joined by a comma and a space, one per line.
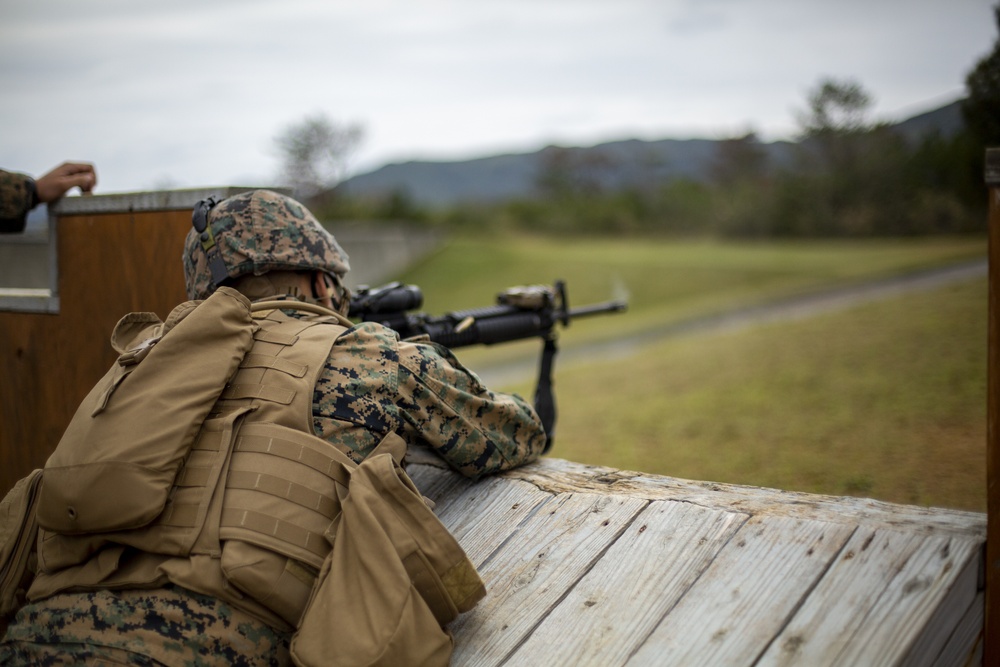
291, 436, 486, 667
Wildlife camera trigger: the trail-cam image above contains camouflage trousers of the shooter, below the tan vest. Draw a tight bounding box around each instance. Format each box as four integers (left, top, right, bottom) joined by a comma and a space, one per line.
0, 587, 291, 667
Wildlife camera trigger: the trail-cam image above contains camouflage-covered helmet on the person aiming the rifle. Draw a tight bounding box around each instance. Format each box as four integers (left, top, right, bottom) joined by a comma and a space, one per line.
184, 190, 350, 299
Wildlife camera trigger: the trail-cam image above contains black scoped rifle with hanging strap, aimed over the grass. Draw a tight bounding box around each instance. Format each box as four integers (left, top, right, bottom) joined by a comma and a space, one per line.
348, 280, 628, 452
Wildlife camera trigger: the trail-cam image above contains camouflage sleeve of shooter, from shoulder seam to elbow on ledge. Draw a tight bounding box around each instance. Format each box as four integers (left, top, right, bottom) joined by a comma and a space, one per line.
399, 342, 545, 478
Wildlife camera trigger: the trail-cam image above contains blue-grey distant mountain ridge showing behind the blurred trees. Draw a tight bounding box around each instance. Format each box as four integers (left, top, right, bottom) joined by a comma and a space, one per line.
338, 102, 962, 207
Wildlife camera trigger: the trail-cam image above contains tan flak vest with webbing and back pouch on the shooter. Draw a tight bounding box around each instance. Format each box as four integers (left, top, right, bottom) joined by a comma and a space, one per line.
28, 288, 368, 630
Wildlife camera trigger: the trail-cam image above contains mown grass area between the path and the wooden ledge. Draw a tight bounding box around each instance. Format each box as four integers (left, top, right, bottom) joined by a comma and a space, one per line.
536, 279, 987, 511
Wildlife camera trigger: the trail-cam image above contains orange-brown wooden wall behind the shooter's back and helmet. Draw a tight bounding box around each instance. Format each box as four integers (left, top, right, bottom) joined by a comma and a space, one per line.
0, 191, 238, 493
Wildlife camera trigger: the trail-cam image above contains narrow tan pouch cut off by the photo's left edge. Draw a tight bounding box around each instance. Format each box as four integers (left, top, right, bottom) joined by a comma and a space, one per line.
0, 469, 42, 637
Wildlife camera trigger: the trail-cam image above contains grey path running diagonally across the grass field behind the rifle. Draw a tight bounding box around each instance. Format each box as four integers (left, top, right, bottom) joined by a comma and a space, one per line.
475, 259, 989, 387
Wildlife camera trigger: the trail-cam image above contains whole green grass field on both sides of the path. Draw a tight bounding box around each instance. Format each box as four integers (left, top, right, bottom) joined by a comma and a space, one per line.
394, 239, 987, 511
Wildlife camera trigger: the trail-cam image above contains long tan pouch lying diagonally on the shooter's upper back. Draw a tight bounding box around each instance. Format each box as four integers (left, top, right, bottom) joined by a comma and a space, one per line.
38, 287, 256, 535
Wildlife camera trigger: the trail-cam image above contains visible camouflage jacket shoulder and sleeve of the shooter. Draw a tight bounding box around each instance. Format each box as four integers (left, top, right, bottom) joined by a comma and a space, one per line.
313, 322, 545, 478
